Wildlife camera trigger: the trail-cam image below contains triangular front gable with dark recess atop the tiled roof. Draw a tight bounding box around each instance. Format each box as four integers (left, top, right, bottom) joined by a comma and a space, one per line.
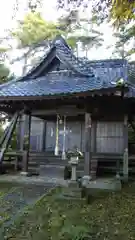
22, 37, 93, 80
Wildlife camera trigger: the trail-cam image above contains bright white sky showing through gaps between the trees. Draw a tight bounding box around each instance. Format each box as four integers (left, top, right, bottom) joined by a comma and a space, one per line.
0, 0, 129, 75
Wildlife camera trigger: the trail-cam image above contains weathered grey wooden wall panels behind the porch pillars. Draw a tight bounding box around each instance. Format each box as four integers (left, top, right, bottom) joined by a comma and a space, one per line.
18, 117, 123, 153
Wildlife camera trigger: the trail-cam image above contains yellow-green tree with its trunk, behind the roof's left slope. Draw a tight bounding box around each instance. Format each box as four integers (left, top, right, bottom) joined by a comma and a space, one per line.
11, 11, 65, 74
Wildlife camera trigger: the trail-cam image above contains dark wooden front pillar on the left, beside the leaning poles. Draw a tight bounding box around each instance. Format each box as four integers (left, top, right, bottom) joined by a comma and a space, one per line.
22, 112, 31, 175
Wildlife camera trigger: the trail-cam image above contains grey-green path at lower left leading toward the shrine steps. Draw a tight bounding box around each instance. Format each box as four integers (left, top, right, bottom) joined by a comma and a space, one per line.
0, 183, 55, 240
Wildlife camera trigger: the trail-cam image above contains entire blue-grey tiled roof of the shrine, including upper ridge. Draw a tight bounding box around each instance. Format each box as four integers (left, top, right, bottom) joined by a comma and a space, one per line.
0, 35, 130, 97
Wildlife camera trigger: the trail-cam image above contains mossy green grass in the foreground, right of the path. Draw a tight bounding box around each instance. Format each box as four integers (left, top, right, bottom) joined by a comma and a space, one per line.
2, 184, 135, 240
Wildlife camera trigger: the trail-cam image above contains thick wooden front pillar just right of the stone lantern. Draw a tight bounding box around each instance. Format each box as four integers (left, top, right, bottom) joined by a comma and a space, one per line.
84, 113, 91, 176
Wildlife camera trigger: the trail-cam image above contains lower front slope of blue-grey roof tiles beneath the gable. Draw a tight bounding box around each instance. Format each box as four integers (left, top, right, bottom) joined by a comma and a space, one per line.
0, 73, 114, 97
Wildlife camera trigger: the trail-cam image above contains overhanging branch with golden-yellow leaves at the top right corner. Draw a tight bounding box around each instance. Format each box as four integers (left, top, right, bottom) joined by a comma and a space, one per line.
57, 0, 135, 26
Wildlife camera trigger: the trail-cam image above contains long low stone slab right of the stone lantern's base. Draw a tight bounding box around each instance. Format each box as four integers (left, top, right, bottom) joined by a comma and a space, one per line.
85, 179, 122, 191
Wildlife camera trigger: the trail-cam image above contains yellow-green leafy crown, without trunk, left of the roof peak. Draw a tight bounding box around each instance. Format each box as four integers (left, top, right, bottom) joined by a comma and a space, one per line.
12, 12, 62, 48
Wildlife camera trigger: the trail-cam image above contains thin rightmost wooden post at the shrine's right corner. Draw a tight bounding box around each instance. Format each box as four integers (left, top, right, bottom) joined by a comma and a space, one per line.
123, 115, 128, 181
